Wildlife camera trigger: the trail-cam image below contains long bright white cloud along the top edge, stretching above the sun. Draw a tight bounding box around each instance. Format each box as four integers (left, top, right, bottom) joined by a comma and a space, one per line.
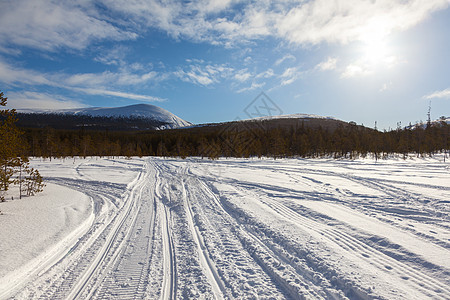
97, 0, 449, 45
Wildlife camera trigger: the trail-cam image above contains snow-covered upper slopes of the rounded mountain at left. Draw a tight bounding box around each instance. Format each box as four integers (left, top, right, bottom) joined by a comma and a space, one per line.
19, 104, 192, 129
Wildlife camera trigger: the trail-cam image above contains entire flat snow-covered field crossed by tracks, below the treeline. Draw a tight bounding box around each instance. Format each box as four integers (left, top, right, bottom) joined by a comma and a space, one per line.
0, 157, 450, 299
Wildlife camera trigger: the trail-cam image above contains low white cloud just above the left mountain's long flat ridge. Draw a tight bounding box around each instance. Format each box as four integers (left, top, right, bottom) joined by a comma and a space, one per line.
8, 92, 86, 109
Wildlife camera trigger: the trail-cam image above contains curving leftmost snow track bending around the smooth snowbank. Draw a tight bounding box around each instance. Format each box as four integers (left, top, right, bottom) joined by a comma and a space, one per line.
12, 164, 146, 299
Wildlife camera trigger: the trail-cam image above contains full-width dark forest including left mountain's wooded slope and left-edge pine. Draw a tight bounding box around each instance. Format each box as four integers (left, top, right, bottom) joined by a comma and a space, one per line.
0, 88, 450, 163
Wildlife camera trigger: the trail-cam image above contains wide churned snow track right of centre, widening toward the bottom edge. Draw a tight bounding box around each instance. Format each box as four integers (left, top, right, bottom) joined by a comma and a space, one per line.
181, 165, 298, 299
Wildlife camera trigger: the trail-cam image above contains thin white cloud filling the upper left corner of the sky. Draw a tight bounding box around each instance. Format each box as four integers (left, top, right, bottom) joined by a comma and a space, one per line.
0, 0, 137, 51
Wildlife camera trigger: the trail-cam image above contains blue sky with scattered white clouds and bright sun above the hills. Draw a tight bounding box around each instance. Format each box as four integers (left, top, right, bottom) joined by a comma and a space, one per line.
0, 0, 450, 129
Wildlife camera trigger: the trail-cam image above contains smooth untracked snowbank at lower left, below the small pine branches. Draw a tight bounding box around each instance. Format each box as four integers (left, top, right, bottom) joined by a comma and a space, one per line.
0, 183, 93, 290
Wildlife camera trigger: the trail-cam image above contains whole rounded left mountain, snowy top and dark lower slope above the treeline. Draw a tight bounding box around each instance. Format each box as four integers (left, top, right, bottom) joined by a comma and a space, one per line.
18, 104, 192, 130
